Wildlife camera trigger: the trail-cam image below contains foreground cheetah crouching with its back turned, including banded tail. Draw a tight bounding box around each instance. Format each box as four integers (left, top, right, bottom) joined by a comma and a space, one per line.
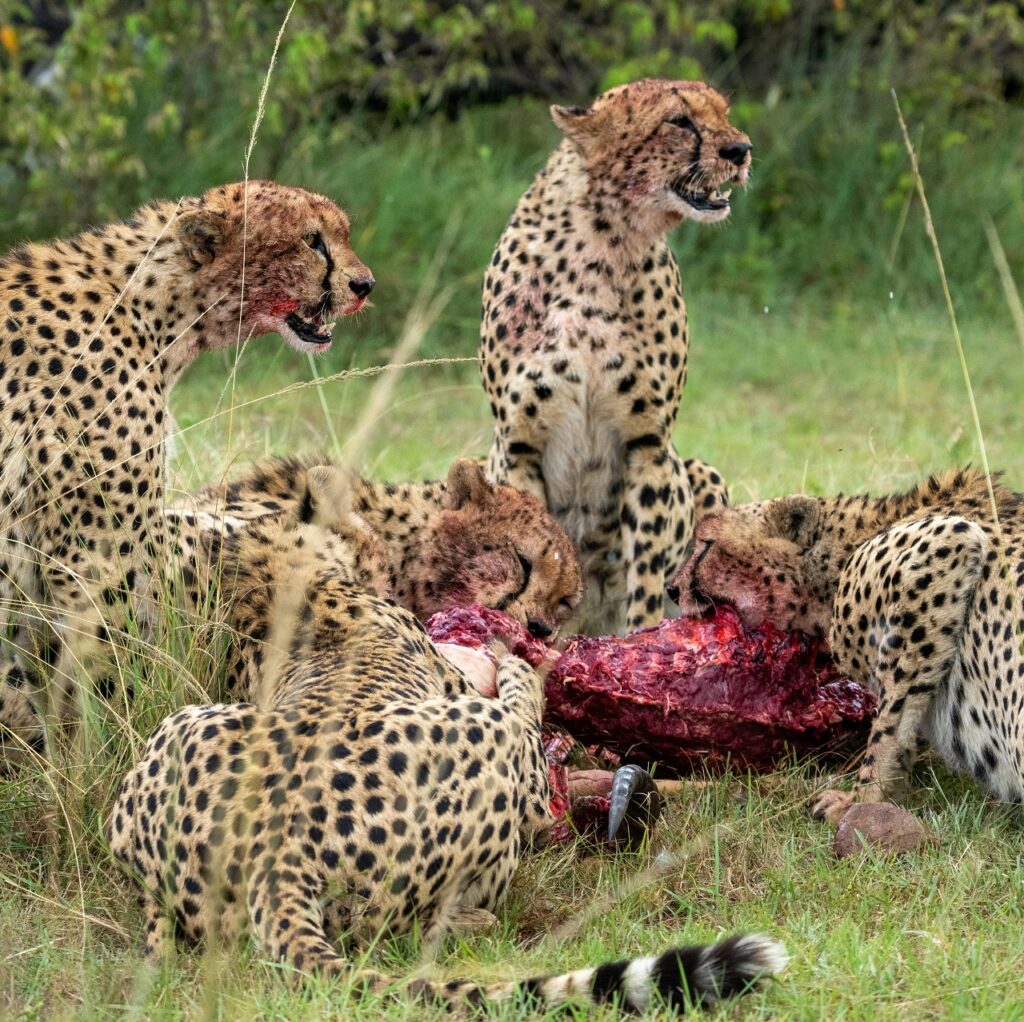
106, 512, 784, 1009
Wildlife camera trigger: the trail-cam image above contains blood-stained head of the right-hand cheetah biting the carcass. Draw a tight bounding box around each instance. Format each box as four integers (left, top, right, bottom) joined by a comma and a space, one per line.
669, 497, 831, 636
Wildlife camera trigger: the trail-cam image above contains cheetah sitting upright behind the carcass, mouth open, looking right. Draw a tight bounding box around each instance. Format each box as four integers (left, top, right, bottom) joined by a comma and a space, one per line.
480, 79, 751, 633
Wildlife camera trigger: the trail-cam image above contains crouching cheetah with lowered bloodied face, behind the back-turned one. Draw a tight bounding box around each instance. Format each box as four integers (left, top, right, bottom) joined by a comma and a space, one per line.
184, 458, 582, 638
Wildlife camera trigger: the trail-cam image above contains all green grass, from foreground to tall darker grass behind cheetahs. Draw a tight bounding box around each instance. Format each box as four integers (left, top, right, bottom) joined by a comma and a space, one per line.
0, 74, 1024, 1022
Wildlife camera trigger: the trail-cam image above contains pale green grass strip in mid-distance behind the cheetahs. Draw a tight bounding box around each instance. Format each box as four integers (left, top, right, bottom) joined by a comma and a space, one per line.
172, 292, 1024, 502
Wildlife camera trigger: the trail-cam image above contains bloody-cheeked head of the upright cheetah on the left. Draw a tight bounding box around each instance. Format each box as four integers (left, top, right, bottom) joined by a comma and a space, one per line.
173, 181, 375, 352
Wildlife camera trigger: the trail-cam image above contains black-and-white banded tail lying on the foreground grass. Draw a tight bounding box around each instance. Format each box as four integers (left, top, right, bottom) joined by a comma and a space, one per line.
407, 934, 788, 1014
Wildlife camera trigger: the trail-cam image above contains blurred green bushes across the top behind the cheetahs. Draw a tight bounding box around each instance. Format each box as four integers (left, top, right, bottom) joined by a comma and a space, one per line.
0, 0, 1024, 319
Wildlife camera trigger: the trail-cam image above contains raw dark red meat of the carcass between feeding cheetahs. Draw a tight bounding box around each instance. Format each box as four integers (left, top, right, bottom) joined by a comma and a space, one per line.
427, 607, 876, 773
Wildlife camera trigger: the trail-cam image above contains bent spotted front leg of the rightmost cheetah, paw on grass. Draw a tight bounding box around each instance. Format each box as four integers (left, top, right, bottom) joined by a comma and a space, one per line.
812, 516, 988, 823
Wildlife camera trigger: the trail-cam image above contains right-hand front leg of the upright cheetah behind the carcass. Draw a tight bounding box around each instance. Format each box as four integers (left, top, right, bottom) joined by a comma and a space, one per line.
621, 433, 679, 632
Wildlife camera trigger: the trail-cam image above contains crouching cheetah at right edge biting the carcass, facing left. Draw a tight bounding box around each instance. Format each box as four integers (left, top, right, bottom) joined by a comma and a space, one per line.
675, 470, 1024, 822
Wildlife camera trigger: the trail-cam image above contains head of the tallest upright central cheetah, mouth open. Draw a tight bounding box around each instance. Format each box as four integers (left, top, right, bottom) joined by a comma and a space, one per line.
551, 78, 751, 229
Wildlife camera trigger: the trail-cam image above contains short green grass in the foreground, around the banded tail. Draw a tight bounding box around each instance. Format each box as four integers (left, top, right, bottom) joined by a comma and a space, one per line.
6, 770, 1024, 1020
